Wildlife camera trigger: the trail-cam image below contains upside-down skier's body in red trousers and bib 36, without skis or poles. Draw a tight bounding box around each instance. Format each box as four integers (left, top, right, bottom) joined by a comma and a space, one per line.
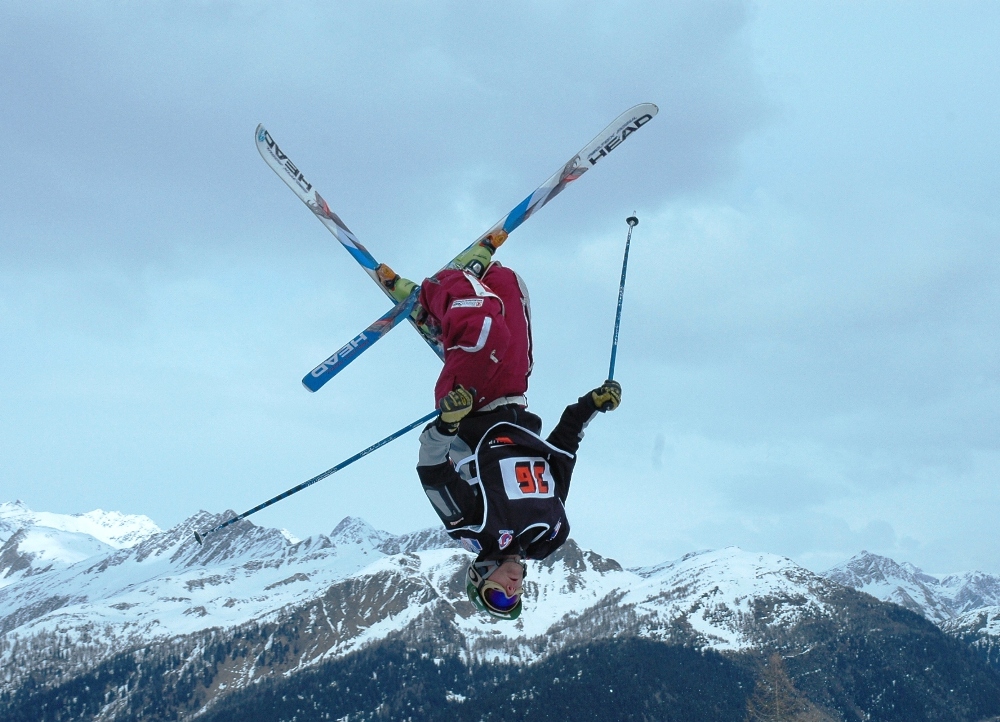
380, 239, 621, 619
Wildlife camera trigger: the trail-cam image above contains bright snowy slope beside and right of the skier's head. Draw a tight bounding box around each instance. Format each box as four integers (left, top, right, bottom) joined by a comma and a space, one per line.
440, 542, 834, 661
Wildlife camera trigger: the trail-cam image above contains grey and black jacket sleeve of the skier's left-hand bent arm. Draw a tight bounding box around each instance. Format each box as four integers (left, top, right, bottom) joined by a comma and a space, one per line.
417, 423, 483, 529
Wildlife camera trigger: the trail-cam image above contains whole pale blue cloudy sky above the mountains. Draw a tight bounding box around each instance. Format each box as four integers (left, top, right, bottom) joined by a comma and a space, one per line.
0, 0, 1000, 573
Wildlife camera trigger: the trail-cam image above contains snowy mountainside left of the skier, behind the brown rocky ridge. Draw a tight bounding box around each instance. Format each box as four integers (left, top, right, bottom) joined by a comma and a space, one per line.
0, 512, 450, 656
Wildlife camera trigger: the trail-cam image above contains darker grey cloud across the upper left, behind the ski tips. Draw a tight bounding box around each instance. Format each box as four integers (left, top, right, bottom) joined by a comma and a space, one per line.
0, 2, 764, 264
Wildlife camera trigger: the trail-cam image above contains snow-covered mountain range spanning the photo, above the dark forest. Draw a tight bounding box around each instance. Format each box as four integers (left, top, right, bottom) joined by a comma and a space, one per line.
0, 503, 1000, 714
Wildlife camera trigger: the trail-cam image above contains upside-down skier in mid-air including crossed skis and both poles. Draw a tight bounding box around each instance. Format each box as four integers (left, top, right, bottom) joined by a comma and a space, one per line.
194, 103, 658, 552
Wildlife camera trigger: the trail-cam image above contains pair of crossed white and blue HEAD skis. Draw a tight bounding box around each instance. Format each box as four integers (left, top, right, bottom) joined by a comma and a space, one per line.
256, 103, 659, 391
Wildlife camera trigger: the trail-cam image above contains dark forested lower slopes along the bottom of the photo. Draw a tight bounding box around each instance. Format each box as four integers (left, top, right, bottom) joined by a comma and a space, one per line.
0, 590, 1000, 722
